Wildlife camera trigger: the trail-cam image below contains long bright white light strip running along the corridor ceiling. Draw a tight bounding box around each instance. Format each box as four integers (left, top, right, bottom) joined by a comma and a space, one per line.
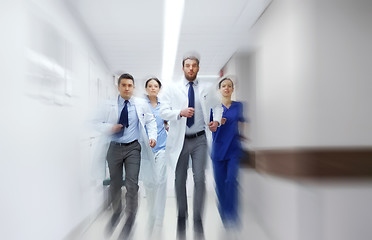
161, 0, 185, 82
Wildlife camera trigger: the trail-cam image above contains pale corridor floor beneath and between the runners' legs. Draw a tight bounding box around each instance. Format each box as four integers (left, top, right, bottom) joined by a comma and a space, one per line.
76, 168, 268, 240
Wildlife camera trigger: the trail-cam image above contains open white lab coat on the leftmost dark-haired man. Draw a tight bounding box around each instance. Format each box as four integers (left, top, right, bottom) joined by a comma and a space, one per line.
92, 97, 157, 178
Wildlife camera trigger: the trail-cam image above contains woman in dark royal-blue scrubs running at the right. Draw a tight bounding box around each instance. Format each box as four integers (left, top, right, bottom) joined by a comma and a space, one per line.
211, 78, 244, 227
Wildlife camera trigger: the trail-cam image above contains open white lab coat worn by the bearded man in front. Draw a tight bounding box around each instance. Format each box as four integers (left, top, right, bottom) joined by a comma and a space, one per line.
159, 80, 223, 169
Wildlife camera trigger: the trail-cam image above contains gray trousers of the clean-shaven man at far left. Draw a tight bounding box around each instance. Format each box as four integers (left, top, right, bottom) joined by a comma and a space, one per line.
107, 142, 141, 216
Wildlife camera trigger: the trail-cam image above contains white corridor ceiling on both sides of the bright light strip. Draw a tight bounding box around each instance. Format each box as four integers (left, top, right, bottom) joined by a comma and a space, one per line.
69, 0, 271, 82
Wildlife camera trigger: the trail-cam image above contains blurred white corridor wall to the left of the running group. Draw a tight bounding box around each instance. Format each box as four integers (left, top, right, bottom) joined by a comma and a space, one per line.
0, 0, 116, 239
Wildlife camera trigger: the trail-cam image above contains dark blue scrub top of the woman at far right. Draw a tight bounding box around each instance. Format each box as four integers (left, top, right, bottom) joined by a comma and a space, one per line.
211, 101, 244, 161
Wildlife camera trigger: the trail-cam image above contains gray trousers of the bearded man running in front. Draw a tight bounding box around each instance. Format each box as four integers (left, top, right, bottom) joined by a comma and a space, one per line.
175, 134, 207, 220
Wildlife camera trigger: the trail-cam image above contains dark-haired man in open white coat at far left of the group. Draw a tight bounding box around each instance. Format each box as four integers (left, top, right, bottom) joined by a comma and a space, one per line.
94, 73, 157, 236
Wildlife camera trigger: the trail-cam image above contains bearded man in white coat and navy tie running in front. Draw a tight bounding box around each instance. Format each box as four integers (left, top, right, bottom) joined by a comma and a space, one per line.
159, 56, 223, 239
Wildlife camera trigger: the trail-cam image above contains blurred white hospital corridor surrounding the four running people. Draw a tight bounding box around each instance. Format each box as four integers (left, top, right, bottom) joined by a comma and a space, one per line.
0, 0, 372, 240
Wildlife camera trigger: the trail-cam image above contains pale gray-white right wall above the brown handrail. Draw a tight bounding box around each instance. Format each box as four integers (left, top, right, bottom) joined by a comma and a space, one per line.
252, 0, 372, 148
